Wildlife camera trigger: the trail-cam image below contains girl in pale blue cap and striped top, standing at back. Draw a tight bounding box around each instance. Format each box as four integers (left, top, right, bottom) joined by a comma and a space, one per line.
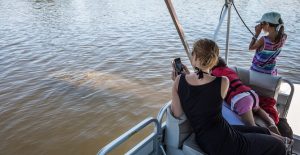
249, 12, 287, 75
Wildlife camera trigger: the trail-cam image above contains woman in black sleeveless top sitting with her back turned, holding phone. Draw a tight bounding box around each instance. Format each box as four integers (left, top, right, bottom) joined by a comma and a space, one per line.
171, 39, 286, 155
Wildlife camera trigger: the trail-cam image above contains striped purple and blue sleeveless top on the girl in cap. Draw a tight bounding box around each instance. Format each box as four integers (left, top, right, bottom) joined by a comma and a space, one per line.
250, 34, 287, 75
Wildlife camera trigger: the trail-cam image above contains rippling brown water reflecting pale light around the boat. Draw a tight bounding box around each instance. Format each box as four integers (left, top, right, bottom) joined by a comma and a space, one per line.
0, 0, 300, 155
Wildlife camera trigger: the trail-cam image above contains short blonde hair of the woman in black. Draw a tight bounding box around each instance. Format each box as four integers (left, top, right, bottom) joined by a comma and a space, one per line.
192, 39, 219, 69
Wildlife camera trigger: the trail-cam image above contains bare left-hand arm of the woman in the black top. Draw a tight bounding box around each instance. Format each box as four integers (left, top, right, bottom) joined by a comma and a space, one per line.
171, 76, 183, 118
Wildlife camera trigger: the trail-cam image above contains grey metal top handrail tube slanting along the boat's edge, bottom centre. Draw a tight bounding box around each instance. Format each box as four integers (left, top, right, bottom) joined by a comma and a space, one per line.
97, 117, 161, 155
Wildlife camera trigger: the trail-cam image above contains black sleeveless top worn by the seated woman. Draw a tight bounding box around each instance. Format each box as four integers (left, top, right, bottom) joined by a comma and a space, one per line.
178, 74, 248, 155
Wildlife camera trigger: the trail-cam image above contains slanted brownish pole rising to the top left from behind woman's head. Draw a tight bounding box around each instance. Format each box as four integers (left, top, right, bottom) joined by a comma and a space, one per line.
165, 0, 192, 64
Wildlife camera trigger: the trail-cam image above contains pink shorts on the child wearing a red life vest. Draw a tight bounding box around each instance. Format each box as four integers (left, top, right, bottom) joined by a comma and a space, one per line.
234, 93, 259, 115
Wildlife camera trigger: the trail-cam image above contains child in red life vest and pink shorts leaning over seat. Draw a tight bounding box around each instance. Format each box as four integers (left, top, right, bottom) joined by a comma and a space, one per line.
212, 57, 280, 134
